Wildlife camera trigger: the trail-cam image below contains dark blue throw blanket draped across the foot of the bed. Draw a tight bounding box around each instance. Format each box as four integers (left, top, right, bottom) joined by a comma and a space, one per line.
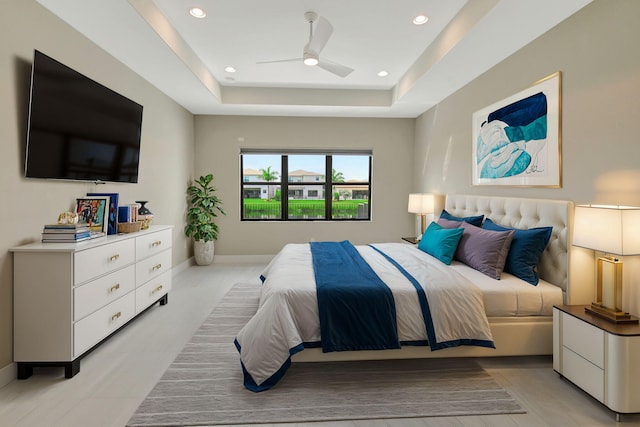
311, 240, 400, 352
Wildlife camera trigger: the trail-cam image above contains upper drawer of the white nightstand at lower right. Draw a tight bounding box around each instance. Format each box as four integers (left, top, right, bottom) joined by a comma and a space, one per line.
562, 314, 604, 369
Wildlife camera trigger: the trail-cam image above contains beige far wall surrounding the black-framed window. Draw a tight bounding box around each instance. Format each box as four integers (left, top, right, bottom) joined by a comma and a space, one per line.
196, 116, 414, 255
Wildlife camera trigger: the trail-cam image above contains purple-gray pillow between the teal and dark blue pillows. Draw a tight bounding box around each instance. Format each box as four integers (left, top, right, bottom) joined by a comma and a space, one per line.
455, 222, 514, 280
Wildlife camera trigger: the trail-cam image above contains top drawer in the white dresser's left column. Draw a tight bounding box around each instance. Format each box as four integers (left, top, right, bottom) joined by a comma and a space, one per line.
73, 239, 135, 285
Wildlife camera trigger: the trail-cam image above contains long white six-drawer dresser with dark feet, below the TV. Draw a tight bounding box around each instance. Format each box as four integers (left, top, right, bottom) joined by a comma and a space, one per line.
11, 225, 172, 379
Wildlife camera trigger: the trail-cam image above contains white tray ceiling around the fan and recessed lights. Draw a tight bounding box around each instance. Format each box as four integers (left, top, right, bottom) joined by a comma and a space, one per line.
37, 0, 591, 117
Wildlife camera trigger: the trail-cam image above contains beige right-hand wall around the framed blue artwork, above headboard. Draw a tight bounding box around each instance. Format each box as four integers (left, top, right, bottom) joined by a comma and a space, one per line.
414, 0, 640, 314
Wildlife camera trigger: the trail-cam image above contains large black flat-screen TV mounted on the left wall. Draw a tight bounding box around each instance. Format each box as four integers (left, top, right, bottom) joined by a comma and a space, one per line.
25, 50, 142, 182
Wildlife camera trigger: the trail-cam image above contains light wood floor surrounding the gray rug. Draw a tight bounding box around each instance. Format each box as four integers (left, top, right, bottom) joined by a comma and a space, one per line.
0, 263, 640, 427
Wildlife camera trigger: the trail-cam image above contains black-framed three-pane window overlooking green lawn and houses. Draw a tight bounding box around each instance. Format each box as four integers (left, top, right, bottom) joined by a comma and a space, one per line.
240, 150, 372, 221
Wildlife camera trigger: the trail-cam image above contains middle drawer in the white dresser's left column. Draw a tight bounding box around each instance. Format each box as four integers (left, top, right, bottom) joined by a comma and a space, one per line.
73, 264, 136, 321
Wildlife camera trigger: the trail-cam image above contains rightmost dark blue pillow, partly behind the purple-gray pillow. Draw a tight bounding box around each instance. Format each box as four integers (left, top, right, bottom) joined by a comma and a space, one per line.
482, 218, 553, 285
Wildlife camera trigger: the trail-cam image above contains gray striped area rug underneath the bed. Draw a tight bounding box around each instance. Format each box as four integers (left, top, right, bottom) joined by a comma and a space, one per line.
127, 284, 525, 427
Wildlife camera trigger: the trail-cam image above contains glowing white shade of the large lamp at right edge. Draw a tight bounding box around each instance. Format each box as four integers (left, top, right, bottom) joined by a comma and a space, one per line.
573, 205, 640, 255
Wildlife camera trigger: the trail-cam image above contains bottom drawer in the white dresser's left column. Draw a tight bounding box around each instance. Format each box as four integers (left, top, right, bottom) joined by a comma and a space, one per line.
73, 292, 136, 358
